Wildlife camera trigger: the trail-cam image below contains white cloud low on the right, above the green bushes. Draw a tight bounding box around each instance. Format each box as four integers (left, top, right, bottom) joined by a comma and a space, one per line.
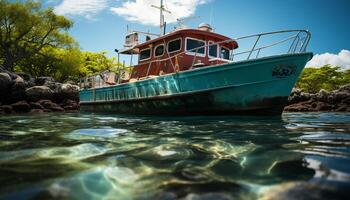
306, 49, 350, 69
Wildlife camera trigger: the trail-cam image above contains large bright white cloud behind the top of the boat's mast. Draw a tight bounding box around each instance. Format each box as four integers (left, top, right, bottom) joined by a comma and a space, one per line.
111, 0, 209, 26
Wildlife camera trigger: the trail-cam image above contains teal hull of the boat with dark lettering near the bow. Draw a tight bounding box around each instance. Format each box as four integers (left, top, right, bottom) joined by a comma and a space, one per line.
80, 53, 312, 115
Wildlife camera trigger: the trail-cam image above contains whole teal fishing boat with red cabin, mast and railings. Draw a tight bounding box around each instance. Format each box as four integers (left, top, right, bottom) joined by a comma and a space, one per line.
80, 1, 313, 115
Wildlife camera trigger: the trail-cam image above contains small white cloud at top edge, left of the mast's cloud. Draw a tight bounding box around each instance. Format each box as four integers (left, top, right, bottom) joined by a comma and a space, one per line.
55, 0, 108, 19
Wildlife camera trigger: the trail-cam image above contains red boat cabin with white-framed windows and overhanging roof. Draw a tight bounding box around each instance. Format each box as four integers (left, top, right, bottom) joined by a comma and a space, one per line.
119, 24, 238, 80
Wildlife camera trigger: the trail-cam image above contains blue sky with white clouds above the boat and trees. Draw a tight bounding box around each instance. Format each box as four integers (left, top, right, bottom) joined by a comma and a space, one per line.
40, 0, 350, 69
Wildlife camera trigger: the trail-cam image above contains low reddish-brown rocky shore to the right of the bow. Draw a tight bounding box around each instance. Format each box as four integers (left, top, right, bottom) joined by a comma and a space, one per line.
284, 84, 350, 112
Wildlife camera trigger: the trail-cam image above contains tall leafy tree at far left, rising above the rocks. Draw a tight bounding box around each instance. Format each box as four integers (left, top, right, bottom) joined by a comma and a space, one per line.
0, 0, 75, 71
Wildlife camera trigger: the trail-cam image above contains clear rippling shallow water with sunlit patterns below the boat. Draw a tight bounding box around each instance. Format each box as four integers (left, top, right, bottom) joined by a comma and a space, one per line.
0, 113, 350, 200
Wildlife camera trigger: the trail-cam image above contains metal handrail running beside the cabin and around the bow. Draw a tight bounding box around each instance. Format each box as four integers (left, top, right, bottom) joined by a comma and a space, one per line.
80, 29, 311, 88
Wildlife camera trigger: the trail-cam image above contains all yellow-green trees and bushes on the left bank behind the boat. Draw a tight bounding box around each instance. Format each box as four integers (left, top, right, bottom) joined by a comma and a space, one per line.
0, 0, 118, 81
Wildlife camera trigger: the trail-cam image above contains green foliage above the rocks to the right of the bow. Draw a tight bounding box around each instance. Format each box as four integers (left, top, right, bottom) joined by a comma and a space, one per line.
296, 65, 350, 93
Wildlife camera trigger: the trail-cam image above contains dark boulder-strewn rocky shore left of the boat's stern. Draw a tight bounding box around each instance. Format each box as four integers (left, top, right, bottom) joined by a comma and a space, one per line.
0, 66, 79, 114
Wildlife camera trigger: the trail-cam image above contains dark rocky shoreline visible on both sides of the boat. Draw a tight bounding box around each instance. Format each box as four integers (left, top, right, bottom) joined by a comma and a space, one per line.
0, 68, 350, 114
